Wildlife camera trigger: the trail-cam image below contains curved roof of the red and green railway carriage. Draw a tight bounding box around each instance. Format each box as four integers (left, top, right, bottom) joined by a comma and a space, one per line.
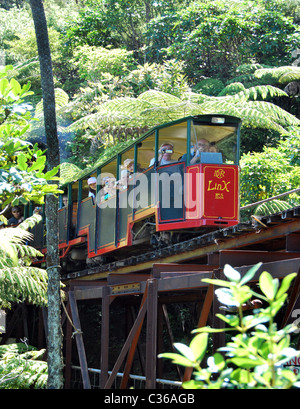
62, 113, 242, 186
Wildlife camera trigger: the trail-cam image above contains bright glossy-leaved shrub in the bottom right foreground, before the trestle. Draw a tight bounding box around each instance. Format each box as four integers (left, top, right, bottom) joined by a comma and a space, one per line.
159, 263, 300, 389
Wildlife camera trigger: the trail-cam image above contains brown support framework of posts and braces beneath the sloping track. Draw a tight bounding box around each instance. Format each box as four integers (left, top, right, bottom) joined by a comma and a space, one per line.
62, 255, 300, 389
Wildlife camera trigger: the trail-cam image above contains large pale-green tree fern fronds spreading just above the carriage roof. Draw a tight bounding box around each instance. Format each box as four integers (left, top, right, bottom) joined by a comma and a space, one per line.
68, 86, 300, 141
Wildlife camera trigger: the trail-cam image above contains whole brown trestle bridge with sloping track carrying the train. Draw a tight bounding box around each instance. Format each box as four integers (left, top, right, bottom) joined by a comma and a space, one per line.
59, 207, 300, 389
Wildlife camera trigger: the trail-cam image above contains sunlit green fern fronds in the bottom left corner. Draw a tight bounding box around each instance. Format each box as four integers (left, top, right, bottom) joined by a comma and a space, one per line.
0, 343, 48, 389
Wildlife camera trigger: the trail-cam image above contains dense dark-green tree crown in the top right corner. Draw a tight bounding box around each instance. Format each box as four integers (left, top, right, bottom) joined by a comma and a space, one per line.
147, 1, 299, 80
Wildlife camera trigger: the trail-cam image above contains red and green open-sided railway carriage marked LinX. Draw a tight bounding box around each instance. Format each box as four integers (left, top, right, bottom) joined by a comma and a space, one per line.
34, 115, 241, 272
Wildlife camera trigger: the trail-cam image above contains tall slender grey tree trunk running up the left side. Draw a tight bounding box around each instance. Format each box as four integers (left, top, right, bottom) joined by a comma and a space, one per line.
30, 0, 63, 389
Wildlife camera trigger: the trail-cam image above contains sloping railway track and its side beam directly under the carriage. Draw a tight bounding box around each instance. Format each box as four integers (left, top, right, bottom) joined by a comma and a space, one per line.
62, 206, 300, 280
